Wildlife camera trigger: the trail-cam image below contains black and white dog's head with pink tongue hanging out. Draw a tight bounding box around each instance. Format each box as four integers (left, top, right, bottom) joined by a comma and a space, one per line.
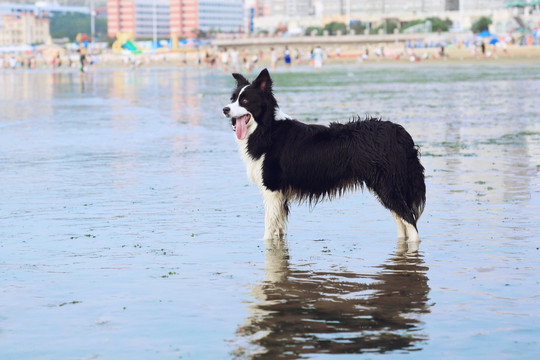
223, 69, 277, 140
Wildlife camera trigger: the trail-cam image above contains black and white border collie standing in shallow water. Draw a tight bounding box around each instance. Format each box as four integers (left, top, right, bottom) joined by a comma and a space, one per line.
223, 69, 426, 242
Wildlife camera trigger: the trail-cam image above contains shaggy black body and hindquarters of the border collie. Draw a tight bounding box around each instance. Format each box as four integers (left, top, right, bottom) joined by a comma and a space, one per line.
255, 118, 426, 225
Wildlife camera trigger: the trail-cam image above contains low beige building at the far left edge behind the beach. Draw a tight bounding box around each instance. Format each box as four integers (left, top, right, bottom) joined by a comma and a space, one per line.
0, 12, 51, 46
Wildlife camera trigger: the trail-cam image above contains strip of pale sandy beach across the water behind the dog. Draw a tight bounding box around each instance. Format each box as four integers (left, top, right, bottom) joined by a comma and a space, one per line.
0, 44, 540, 74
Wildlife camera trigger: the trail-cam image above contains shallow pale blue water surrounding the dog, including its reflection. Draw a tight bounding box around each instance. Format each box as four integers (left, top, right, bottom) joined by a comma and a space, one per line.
0, 64, 540, 359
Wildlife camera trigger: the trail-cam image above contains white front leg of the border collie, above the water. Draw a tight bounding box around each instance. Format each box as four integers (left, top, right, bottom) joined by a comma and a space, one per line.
263, 189, 288, 239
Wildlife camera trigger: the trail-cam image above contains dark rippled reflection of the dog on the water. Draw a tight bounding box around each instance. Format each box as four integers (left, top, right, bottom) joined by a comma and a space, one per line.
234, 240, 429, 359
